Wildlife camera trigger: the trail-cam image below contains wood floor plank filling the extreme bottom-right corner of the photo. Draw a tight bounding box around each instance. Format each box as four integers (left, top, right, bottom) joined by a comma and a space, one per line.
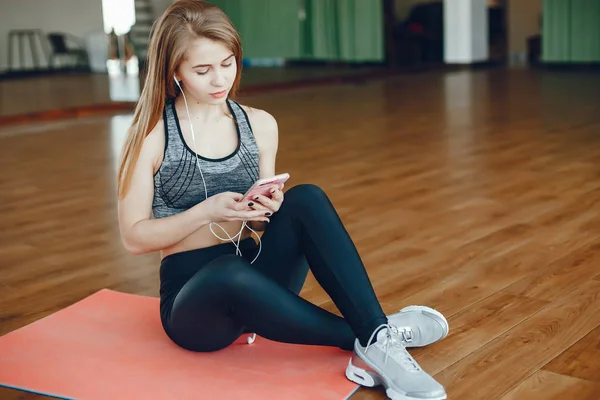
500, 370, 600, 400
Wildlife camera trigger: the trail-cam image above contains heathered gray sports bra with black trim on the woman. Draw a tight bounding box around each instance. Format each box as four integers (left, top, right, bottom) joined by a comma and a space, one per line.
152, 100, 259, 218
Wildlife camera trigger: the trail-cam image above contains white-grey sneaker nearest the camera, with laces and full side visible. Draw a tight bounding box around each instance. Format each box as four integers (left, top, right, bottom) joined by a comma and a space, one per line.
346, 324, 447, 400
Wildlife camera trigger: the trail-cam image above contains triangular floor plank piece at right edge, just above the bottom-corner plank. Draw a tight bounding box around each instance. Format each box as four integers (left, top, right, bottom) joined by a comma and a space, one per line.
543, 326, 600, 382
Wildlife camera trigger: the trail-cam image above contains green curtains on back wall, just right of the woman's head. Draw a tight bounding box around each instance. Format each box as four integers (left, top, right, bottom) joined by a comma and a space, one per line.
212, 0, 384, 62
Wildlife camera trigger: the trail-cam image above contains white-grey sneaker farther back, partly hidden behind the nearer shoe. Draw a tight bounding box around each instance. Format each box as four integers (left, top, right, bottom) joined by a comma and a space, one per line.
388, 306, 450, 347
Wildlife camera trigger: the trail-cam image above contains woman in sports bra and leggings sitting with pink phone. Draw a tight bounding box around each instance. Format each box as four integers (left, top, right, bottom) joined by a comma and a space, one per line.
119, 0, 448, 399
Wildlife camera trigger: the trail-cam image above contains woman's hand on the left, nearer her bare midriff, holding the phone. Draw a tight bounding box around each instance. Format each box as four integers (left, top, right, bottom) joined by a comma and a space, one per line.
200, 192, 269, 222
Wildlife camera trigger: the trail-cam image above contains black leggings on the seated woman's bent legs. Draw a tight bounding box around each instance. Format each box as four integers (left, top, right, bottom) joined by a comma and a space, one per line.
160, 185, 387, 351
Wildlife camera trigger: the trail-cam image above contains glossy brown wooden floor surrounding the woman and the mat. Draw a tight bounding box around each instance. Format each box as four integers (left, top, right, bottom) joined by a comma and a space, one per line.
0, 70, 600, 400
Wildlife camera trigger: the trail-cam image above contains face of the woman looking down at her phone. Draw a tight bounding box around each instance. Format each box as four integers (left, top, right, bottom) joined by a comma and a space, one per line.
177, 38, 237, 104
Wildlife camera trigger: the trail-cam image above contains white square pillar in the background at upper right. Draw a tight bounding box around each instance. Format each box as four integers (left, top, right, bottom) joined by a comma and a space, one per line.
444, 0, 489, 64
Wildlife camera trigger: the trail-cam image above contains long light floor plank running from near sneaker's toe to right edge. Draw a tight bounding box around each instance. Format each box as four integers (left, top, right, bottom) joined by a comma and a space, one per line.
436, 281, 600, 399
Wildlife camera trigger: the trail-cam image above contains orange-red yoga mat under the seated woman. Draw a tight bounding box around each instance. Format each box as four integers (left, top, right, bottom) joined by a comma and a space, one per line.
0, 289, 358, 400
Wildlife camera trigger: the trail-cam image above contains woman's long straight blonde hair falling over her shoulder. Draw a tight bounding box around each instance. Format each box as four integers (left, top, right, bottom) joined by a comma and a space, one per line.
118, 0, 242, 198
